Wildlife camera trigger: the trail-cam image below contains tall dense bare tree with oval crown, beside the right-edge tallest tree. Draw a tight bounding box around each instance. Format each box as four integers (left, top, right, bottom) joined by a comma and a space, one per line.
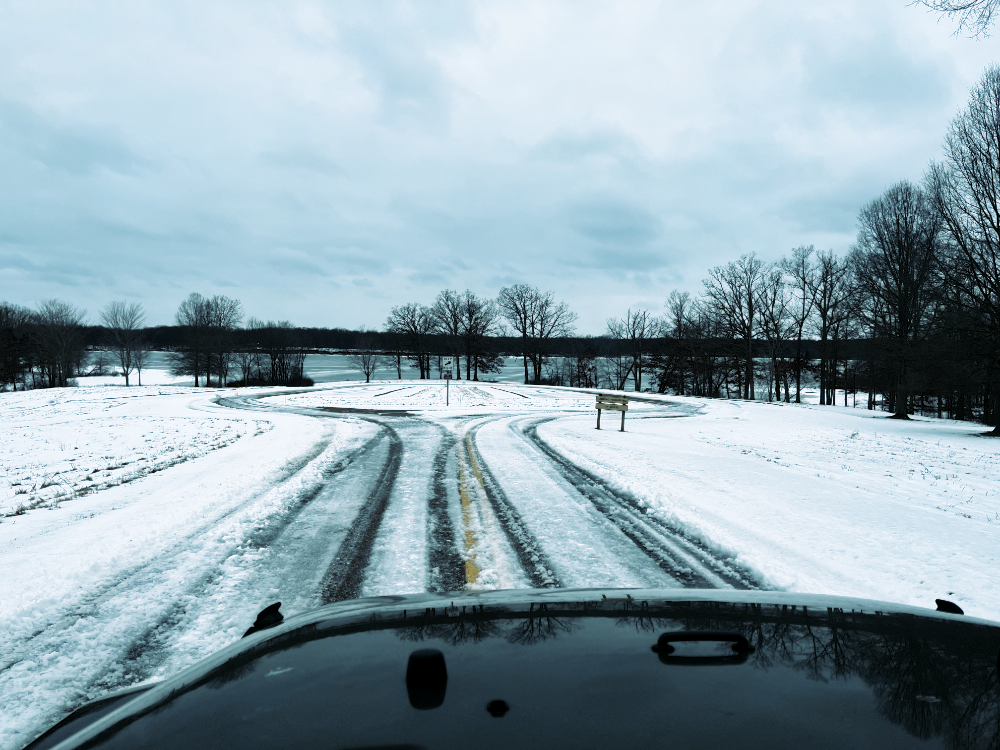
850, 181, 941, 419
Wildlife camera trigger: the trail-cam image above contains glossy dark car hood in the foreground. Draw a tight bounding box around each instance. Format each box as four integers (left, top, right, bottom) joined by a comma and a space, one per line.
29, 589, 1000, 750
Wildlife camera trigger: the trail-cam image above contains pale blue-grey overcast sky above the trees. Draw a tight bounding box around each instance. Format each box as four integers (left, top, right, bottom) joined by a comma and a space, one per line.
0, 0, 998, 334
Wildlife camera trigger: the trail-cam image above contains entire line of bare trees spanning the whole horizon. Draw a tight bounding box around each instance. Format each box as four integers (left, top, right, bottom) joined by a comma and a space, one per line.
0, 66, 1000, 432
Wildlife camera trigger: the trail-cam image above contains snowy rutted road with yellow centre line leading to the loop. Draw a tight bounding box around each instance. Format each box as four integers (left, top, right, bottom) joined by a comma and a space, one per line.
220, 383, 758, 603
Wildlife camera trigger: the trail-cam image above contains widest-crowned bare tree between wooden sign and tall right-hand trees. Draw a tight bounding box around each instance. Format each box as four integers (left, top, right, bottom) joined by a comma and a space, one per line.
703, 253, 764, 400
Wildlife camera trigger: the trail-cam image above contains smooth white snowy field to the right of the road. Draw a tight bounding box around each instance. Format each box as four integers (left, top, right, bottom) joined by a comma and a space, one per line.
538, 398, 1000, 620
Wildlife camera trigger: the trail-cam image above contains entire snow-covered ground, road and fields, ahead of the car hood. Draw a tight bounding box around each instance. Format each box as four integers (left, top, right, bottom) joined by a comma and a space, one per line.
0, 381, 1000, 750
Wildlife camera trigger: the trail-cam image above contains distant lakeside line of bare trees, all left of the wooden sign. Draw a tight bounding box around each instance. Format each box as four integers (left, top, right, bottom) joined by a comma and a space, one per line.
0, 284, 576, 390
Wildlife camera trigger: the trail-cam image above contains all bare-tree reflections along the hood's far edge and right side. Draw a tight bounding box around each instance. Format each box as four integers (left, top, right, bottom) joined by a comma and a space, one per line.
397, 602, 1000, 748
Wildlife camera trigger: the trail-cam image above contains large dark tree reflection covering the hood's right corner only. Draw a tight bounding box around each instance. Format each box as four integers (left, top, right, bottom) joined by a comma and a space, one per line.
656, 604, 1000, 749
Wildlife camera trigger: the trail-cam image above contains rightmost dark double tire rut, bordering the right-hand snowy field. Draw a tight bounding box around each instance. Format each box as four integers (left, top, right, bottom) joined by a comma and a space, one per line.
511, 417, 762, 590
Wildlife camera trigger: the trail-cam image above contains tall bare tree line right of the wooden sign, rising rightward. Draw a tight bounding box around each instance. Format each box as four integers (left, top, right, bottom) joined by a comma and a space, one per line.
608, 66, 1000, 432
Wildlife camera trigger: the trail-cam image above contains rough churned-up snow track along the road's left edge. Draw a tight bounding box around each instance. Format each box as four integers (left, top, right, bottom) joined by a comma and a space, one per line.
0, 424, 377, 748
